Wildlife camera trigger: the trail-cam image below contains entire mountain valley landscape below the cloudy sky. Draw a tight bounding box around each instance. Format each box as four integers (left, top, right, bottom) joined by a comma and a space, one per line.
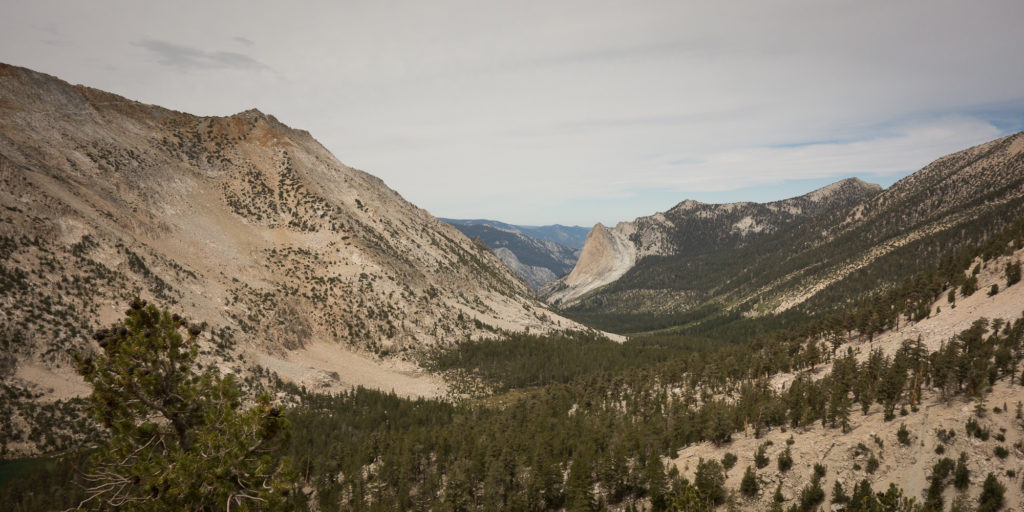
0, 60, 1024, 512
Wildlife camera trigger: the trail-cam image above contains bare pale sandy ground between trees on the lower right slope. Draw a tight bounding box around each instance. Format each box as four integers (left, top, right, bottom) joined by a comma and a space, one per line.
669, 245, 1024, 511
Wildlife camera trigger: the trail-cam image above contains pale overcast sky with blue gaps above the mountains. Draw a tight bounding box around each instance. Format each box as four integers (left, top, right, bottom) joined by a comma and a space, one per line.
0, 0, 1024, 226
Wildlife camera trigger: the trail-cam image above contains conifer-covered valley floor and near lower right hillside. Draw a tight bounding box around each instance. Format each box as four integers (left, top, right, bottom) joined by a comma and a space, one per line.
2, 216, 1024, 511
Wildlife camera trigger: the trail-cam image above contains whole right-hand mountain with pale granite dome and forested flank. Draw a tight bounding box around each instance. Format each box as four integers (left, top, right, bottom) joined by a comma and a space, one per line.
542, 133, 1024, 329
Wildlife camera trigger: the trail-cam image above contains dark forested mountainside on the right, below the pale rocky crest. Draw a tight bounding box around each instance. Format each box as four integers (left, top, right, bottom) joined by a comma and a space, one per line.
565, 133, 1024, 333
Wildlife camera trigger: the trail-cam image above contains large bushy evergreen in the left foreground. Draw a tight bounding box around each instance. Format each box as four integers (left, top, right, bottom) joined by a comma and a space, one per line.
76, 299, 294, 510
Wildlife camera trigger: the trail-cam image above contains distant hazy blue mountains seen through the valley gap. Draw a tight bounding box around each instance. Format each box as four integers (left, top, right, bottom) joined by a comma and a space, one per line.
441, 219, 582, 290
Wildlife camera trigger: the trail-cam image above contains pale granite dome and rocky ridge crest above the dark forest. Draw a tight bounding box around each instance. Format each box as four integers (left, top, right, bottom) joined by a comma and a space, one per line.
544, 178, 882, 306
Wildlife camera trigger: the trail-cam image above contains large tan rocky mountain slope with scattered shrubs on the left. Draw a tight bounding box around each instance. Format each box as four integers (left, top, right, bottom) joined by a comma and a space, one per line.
0, 65, 574, 456
